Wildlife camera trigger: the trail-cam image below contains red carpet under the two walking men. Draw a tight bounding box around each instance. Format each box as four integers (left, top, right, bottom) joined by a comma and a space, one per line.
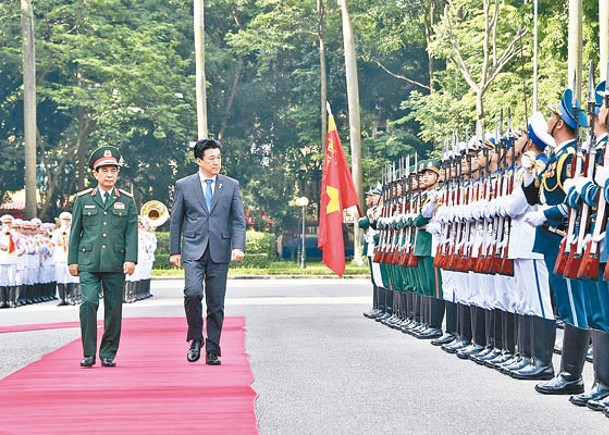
0, 317, 258, 434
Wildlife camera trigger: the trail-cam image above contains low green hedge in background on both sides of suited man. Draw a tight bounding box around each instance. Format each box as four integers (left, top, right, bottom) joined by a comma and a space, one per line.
154, 230, 275, 269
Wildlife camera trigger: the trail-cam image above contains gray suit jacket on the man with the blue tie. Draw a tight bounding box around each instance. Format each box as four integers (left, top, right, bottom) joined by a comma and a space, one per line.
169, 173, 245, 263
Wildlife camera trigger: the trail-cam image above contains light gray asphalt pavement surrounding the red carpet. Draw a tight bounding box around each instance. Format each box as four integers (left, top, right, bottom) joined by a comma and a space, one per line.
0, 279, 609, 434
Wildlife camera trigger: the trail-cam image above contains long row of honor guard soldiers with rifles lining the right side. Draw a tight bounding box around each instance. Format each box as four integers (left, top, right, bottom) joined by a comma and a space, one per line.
359, 65, 609, 417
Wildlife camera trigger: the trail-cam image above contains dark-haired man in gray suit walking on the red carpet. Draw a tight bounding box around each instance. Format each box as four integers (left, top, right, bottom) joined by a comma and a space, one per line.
170, 139, 245, 365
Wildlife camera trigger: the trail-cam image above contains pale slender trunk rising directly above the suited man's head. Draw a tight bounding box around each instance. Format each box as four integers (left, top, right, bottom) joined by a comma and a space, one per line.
194, 0, 209, 139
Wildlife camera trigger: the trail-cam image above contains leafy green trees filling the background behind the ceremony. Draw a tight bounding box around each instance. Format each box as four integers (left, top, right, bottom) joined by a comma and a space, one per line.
0, 0, 598, 227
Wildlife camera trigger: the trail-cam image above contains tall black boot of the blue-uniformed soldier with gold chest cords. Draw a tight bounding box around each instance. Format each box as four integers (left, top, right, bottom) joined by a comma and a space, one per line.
535, 323, 590, 394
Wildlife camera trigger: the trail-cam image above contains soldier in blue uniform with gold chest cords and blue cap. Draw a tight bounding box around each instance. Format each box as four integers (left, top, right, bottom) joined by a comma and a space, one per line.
523, 89, 590, 394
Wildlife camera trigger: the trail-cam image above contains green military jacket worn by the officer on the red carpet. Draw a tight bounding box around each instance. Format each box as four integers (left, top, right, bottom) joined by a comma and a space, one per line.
68, 187, 138, 272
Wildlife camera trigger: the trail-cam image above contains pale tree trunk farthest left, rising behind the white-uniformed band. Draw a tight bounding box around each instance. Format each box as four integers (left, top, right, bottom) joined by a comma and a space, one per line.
21, 0, 37, 219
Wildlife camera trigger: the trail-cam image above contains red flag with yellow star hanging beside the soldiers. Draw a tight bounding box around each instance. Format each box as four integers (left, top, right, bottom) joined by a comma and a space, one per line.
317, 113, 361, 276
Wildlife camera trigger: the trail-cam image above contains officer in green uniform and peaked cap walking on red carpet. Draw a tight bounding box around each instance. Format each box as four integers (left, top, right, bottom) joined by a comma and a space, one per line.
68, 146, 137, 367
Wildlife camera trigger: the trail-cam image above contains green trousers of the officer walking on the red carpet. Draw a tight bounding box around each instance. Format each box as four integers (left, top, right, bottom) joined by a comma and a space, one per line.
79, 272, 125, 359
